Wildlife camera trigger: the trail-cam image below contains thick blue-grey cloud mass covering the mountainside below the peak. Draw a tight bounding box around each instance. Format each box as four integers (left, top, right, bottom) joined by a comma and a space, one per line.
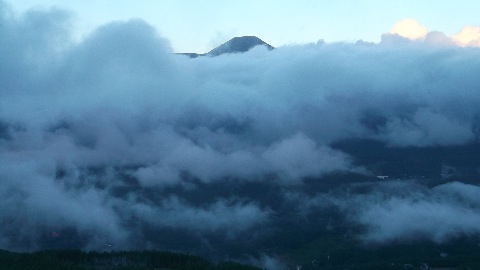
0, 2, 480, 258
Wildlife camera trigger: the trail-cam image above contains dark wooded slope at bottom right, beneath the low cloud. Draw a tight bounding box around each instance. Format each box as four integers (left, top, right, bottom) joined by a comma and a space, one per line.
289, 235, 480, 270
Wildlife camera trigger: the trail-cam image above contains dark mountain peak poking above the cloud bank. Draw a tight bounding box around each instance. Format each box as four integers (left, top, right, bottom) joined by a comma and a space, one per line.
207, 36, 274, 56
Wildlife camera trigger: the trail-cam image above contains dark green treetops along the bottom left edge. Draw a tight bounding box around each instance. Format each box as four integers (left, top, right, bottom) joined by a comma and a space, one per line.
0, 250, 259, 270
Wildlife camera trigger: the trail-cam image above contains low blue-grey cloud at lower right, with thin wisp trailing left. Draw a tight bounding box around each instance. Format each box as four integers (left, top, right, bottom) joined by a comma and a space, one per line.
289, 181, 480, 244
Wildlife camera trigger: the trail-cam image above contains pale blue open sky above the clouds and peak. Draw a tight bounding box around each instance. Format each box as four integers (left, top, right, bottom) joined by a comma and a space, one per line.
8, 0, 480, 53
